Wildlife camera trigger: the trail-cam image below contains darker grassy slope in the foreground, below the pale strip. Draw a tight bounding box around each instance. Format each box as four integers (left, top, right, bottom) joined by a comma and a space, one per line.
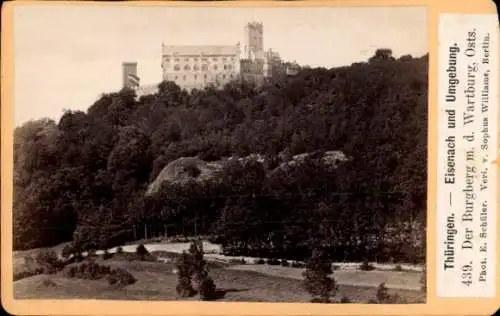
14, 258, 425, 303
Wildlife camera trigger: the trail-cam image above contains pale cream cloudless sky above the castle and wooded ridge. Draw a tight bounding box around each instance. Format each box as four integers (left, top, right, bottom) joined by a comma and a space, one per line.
14, 5, 428, 125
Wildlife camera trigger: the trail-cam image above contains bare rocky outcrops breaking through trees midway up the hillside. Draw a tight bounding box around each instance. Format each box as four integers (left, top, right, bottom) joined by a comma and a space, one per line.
146, 150, 349, 195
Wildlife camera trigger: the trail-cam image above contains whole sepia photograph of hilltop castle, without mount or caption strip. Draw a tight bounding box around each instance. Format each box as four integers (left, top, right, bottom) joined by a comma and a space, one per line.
12, 4, 429, 304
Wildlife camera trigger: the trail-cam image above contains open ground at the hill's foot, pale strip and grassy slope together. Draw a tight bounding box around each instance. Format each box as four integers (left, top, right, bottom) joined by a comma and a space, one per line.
13, 242, 425, 302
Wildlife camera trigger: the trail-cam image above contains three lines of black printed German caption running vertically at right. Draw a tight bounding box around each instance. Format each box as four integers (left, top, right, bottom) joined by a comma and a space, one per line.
437, 17, 496, 298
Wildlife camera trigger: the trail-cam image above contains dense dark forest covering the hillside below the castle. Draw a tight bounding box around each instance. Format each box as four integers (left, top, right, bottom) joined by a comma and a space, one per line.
13, 50, 428, 262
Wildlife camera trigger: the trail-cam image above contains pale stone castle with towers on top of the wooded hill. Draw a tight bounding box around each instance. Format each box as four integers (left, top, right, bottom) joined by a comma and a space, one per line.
123, 22, 298, 96
